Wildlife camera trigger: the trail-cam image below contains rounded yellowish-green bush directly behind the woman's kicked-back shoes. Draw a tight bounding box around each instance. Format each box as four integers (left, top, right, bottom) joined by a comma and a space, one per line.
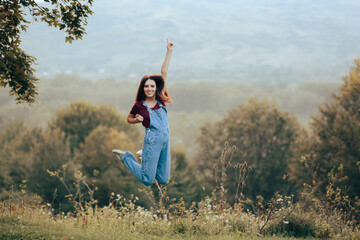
75, 125, 140, 206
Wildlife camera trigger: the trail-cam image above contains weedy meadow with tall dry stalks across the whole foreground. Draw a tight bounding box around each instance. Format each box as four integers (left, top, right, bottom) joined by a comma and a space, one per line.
0, 156, 360, 240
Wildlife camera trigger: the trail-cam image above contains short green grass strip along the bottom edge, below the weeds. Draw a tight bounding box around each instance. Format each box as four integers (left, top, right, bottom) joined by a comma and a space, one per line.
0, 217, 314, 240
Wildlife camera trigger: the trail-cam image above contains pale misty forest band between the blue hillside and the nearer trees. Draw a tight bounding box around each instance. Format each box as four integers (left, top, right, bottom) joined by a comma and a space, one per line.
0, 75, 339, 157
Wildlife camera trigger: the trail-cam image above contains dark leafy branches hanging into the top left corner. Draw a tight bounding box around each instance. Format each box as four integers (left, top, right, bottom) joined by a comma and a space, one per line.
0, 0, 93, 103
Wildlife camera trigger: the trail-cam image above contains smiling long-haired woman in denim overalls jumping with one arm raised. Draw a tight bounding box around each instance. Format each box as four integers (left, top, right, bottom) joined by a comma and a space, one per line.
112, 40, 174, 186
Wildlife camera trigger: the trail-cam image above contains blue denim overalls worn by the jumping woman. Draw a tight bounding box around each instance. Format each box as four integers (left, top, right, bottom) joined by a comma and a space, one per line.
121, 101, 170, 186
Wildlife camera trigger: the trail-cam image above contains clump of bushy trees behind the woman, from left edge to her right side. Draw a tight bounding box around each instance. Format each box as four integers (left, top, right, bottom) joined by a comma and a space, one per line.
0, 101, 201, 212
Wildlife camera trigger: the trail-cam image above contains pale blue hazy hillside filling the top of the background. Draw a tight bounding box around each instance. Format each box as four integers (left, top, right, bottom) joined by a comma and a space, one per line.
22, 0, 360, 84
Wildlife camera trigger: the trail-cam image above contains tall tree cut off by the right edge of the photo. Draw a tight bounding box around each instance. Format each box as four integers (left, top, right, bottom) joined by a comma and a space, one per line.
290, 59, 360, 199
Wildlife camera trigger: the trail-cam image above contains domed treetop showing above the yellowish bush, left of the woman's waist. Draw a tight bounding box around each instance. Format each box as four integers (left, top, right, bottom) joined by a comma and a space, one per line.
50, 101, 139, 151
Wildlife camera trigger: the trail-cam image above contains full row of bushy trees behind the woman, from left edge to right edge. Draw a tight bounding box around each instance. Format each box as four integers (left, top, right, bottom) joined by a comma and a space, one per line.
0, 59, 360, 223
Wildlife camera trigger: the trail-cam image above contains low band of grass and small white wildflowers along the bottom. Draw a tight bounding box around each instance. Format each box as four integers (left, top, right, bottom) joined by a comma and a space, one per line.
0, 195, 360, 240
